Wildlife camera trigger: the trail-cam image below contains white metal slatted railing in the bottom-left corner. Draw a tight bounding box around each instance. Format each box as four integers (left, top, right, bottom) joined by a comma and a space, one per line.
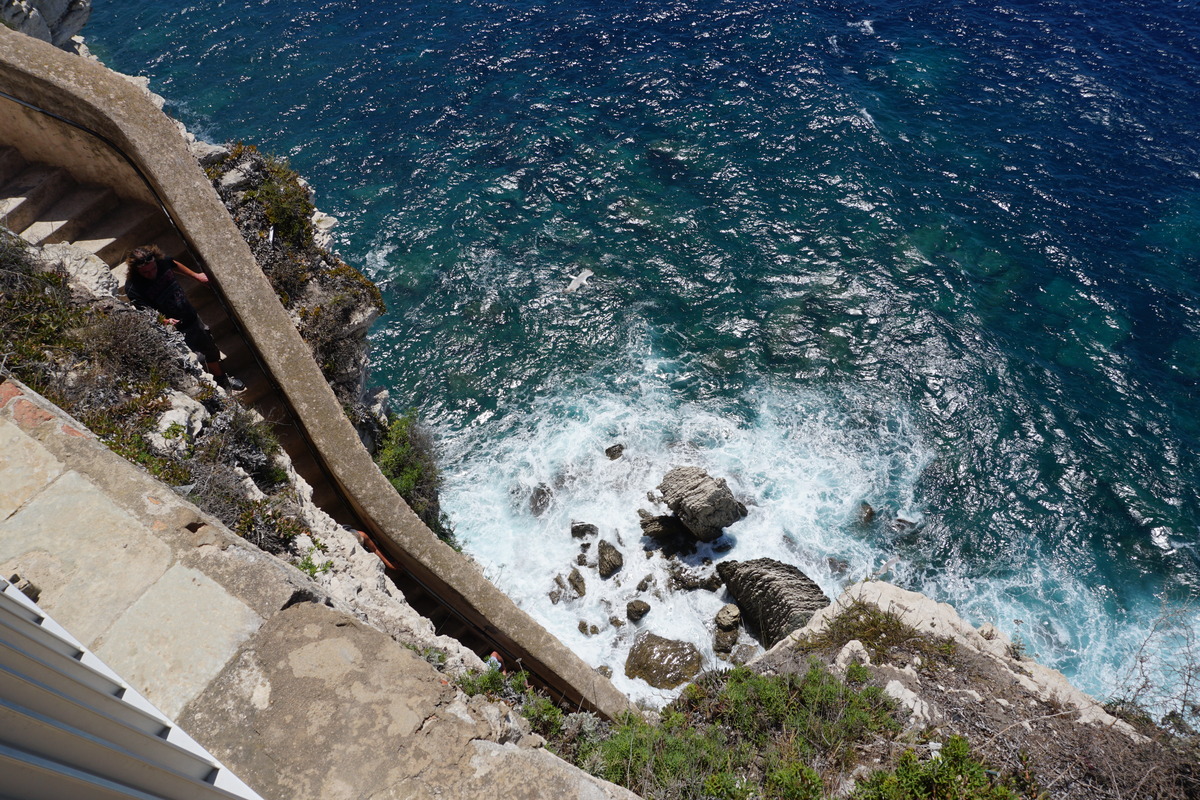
0, 578, 262, 800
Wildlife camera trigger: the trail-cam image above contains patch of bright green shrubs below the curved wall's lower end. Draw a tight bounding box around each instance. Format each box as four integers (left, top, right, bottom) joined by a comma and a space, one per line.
561, 662, 900, 800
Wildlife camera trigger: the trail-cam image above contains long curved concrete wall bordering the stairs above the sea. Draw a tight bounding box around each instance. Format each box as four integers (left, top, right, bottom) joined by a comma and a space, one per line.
0, 29, 629, 716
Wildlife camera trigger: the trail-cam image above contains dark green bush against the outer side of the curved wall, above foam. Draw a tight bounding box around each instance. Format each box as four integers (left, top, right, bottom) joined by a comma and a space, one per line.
376, 409, 458, 549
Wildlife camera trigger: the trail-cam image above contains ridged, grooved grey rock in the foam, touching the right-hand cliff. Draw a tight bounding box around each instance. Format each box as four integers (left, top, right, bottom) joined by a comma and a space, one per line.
716, 558, 829, 648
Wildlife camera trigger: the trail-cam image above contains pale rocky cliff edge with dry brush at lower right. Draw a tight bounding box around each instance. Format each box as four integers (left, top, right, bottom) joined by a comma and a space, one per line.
748, 581, 1200, 800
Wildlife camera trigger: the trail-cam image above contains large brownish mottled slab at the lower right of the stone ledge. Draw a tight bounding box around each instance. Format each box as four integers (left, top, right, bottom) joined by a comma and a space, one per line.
180, 603, 634, 800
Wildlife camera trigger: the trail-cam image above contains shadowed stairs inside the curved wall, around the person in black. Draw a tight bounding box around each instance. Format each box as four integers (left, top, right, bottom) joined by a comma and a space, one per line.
0, 148, 353, 523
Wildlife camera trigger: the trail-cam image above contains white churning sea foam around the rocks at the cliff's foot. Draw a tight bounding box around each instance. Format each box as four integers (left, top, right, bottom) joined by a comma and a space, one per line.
443, 362, 929, 700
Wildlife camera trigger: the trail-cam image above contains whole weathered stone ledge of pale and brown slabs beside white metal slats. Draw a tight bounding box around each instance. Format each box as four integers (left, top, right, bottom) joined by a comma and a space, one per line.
0, 380, 635, 800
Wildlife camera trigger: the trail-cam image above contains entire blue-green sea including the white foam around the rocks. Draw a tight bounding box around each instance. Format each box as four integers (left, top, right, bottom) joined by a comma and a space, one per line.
85, 0, 1200, 697
